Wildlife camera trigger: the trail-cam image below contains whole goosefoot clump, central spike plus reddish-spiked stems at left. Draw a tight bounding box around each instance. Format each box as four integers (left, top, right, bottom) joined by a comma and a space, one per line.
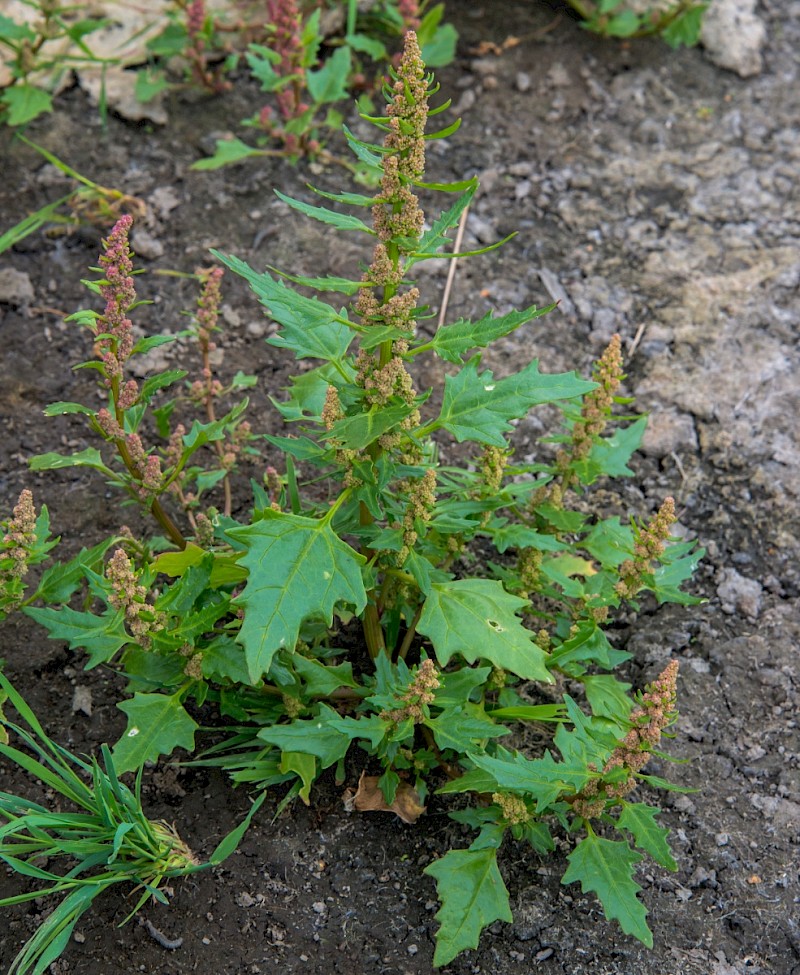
7, 32, 702, 965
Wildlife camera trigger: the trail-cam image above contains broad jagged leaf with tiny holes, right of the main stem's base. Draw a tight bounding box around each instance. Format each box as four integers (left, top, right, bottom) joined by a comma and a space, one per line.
417, 579, 553, 683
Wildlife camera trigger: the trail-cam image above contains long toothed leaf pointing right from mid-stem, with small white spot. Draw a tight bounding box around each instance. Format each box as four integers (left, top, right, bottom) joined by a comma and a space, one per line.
426, 359, 596, 447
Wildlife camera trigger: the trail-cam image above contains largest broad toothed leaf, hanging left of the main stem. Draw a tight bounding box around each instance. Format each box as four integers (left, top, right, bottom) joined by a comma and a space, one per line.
227, 510, 367, 682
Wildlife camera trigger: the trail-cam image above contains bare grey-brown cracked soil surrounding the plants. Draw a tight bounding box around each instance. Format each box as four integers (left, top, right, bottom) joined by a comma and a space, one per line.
0, 0, 800, 975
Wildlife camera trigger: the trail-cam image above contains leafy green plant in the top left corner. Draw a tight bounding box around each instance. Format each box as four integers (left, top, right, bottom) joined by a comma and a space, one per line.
0, 0, 113, 125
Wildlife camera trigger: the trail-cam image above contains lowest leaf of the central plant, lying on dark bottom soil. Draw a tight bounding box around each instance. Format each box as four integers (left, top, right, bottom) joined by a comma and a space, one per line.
423, 847, 513, 967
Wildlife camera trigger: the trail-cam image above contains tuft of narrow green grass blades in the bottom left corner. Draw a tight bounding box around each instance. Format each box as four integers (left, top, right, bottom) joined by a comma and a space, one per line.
0, 674, 263, 975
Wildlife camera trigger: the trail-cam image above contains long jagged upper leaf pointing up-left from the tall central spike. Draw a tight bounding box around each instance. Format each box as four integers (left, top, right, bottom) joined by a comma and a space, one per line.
211, 251, 355, 362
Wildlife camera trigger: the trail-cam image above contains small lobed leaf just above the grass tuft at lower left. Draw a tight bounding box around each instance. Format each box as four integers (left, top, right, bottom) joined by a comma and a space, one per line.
113, 694, 199, 772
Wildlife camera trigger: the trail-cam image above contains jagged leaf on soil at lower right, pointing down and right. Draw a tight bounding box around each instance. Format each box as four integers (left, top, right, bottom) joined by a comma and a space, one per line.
561, 834, 653, 948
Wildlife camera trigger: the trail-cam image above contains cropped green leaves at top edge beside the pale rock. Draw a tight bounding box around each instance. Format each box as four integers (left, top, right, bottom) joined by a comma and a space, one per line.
569, 0, 708, 47
